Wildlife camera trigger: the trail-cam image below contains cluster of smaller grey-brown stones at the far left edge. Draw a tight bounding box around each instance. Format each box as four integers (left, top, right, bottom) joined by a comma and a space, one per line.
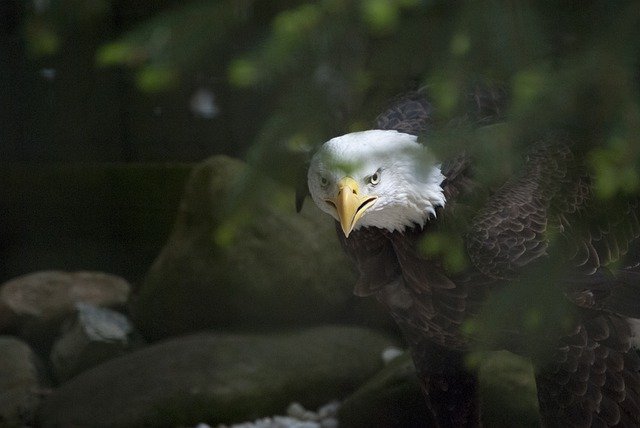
0, 271, 134, 426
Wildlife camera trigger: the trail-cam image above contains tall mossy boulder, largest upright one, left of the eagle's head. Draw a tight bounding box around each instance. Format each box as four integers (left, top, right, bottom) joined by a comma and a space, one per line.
132, 156, 389, 339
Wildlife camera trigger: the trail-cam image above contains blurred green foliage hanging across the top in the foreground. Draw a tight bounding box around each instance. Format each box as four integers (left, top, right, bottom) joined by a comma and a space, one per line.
18, 0, 640, 194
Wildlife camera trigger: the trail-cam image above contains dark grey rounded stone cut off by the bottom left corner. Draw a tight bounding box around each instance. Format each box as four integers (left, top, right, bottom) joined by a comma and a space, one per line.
0, 336, 48, 427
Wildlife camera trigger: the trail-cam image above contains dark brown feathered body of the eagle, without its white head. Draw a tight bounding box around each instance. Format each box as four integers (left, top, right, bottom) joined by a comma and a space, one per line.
338, 89, 640, 427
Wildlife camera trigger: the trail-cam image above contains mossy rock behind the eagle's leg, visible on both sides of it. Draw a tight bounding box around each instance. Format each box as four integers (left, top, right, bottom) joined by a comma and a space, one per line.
338, 351, 540, 428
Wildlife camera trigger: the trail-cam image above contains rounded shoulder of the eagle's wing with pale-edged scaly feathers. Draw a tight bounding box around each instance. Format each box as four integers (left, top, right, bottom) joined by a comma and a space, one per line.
466, 144, 572, 279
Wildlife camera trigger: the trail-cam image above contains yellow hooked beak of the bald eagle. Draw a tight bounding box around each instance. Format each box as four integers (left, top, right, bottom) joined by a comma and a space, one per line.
325, 177, 378, 238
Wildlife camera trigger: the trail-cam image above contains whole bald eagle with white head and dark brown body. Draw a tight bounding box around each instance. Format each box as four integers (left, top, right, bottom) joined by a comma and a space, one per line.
300, 88, 640, 427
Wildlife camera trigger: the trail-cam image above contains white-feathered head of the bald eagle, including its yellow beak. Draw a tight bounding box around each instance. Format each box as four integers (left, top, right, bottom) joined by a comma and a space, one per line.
307, 130, 445, 237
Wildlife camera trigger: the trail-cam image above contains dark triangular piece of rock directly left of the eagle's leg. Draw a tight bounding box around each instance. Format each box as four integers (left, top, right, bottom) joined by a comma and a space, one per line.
338, 353, 435, 428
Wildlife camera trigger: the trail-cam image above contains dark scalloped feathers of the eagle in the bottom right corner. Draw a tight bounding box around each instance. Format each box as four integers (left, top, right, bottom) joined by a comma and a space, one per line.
536, 314, 640, 427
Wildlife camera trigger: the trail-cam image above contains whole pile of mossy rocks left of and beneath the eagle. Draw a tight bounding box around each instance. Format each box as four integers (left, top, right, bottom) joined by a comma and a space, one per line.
0, 156, 530, 428
